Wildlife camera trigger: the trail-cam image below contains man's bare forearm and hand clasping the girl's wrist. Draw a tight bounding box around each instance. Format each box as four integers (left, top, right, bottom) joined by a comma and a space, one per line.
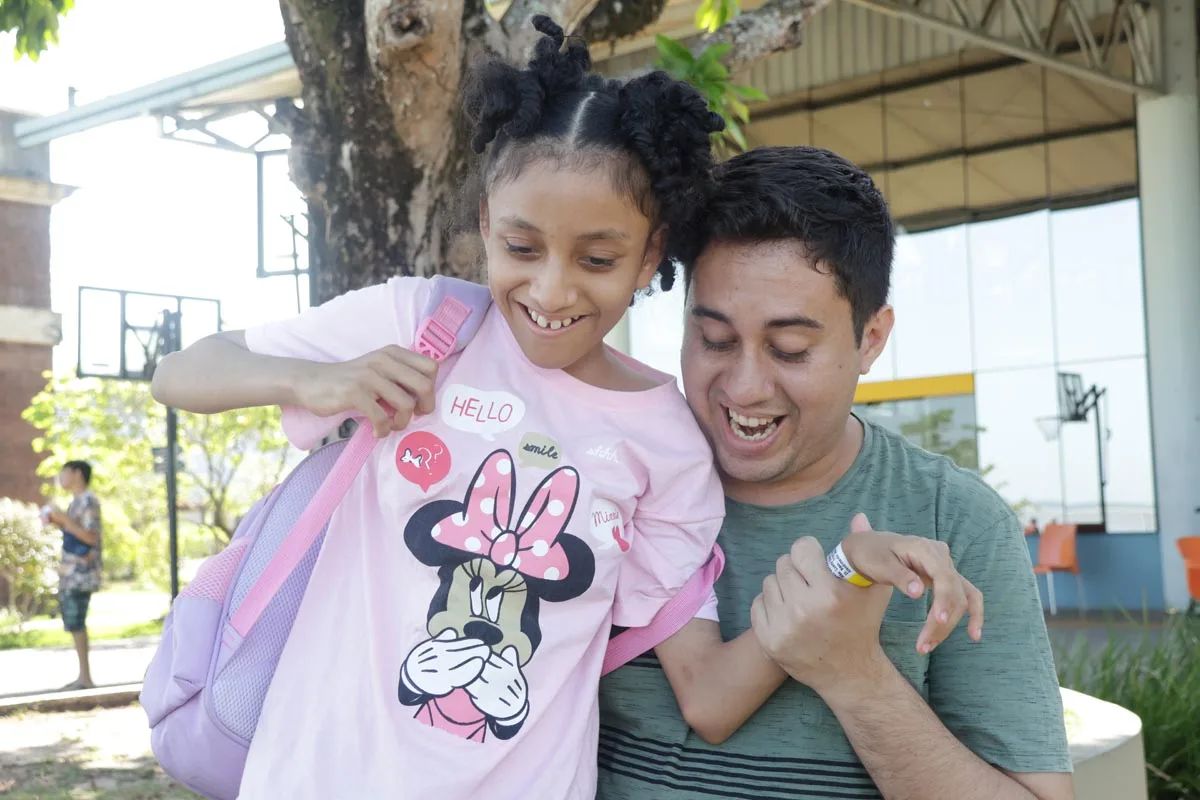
751, 539, 1074, 800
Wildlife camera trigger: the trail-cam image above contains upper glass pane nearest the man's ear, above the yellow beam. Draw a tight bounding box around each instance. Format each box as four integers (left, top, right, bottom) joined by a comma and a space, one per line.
892, 225, 971, 378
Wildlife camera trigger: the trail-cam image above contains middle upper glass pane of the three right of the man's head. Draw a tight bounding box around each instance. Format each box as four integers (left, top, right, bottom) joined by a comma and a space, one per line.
967, 212, 1054, 371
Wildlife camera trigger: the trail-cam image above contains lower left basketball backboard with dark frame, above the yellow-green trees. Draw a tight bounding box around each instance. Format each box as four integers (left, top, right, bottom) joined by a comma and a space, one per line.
77, 287, 221, 380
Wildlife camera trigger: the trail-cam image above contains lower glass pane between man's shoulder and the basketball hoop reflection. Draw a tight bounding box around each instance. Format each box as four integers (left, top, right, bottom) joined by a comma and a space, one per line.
976, 367, 1064, 532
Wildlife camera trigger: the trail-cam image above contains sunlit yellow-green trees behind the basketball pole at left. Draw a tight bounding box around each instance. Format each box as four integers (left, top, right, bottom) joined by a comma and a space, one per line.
23, 378, 296, 587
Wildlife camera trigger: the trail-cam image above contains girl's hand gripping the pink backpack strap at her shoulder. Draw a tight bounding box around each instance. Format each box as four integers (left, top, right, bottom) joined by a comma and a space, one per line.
293, 344, 438, 439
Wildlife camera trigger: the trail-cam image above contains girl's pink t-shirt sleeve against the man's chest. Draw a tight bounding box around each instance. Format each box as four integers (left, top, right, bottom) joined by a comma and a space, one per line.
613, 447, 725, 627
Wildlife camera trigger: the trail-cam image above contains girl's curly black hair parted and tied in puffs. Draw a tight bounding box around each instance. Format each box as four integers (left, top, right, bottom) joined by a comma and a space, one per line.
464, 16, 725, 290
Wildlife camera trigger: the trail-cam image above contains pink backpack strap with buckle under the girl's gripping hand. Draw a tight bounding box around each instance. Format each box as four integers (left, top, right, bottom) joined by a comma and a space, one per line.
229, 276, 491, 637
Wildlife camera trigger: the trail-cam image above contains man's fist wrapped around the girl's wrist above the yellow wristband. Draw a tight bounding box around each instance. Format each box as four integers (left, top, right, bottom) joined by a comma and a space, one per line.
750, 537, 892, 693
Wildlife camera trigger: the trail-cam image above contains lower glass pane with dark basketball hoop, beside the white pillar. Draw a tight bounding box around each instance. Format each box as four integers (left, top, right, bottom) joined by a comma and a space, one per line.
1061, 359, 1158, 533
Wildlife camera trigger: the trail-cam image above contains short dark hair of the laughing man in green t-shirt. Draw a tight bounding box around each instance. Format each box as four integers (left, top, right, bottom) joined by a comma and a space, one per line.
684, 148, 895, 341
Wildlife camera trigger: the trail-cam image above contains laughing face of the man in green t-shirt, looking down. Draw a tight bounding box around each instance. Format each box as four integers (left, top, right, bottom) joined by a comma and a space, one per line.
683, 241, 893, 497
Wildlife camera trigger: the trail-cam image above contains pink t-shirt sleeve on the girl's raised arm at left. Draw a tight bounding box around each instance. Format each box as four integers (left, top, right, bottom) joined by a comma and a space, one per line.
246, 277, 430, 450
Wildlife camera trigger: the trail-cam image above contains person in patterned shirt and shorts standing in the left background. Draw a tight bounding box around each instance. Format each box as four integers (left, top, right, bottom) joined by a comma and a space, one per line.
48, 461, 101, 691
